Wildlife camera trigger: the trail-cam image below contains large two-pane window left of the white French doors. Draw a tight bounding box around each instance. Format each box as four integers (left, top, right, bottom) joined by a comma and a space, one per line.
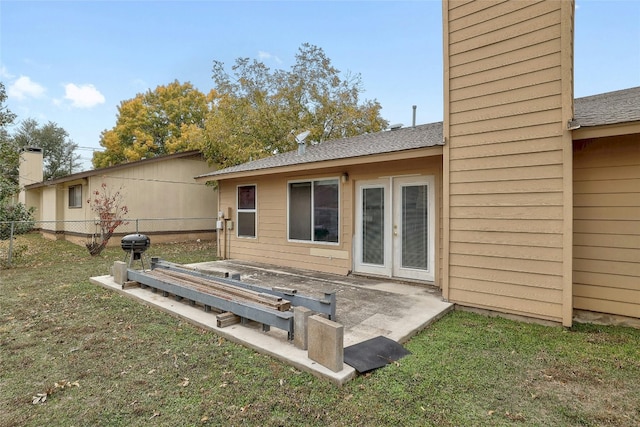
289, 179, 339, 243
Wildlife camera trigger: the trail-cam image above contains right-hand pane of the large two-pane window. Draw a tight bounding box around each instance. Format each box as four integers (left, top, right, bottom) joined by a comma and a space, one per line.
313, 179, 339, 242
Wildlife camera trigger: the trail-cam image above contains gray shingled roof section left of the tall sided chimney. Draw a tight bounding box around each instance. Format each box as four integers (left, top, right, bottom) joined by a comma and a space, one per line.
200, 122, 443, 177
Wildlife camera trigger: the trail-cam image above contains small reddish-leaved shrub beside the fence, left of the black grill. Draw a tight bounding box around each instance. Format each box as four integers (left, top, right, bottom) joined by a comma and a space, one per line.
86, 182, 129, 256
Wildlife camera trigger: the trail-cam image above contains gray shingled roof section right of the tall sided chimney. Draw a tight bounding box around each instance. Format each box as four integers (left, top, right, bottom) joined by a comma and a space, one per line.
574, 87, 640, 127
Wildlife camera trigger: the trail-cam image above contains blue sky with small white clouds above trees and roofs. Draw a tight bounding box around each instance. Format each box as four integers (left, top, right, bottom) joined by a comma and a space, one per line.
0, 0, 640, 168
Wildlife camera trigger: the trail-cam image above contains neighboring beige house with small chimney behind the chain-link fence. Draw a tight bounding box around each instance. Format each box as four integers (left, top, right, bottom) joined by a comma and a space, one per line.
19, 149, 218, 244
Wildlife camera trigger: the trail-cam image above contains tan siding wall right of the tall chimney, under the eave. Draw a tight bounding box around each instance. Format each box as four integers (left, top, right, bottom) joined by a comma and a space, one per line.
573, 135, 640, 317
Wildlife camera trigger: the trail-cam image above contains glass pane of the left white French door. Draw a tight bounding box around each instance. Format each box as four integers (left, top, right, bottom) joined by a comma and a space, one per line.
362, 188, 384, 265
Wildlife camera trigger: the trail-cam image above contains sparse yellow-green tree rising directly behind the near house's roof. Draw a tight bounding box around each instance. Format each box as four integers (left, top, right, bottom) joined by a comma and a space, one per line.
204, 44, 387, 166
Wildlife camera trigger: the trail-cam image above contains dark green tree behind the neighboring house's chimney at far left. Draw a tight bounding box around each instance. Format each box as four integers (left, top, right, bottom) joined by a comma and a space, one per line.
13, 119, 80, 180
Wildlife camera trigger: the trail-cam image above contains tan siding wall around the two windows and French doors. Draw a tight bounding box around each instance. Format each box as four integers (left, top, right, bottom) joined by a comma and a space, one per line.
219, 155, 442, 280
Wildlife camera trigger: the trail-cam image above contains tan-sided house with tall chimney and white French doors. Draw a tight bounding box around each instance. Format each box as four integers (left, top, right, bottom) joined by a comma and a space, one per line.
196, 0, 640, 326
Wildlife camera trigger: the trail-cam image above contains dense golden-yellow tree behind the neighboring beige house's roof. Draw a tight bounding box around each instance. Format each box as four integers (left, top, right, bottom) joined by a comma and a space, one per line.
93, 80, 208, 168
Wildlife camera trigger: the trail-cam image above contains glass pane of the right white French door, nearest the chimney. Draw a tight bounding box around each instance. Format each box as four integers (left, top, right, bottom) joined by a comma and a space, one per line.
402, 185, 429, 270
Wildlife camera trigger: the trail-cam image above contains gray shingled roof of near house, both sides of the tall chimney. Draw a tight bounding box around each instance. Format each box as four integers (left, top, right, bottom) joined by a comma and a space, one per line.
200, 87, 640, 181
